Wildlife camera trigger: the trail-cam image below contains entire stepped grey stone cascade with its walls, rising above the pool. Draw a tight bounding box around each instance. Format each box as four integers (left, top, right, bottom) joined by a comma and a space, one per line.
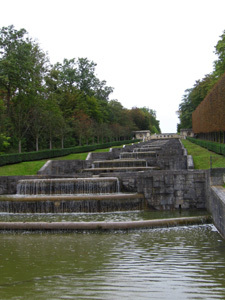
0, 140, 213, 231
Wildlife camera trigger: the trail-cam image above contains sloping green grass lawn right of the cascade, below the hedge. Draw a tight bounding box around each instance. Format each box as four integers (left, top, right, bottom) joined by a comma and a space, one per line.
181, 140, 225, 169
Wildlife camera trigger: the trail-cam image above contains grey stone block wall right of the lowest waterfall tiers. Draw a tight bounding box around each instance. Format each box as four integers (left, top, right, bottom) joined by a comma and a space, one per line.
101, 170, 208, 210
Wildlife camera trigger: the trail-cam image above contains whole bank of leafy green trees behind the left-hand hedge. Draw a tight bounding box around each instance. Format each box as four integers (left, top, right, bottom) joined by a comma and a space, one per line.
0, 25, 160, 152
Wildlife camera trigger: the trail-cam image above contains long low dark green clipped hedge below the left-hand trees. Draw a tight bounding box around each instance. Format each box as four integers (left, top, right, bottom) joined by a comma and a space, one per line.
0, 140, 139, 166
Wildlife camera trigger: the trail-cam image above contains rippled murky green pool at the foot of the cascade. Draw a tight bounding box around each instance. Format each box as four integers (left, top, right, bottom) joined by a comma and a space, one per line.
0, 225, 225, 300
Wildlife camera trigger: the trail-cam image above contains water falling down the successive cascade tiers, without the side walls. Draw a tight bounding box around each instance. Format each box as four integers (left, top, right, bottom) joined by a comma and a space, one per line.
0, 144, 169, 213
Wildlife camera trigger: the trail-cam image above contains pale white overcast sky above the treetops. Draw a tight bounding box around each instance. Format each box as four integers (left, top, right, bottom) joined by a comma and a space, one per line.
0, 0, 225, 133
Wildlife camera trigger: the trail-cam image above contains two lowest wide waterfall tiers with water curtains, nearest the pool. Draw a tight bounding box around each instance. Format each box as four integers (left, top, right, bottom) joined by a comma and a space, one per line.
0, 177, 145, 213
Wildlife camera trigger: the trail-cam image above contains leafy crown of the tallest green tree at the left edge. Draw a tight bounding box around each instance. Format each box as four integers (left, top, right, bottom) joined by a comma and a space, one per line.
0, 25, 47, 113
